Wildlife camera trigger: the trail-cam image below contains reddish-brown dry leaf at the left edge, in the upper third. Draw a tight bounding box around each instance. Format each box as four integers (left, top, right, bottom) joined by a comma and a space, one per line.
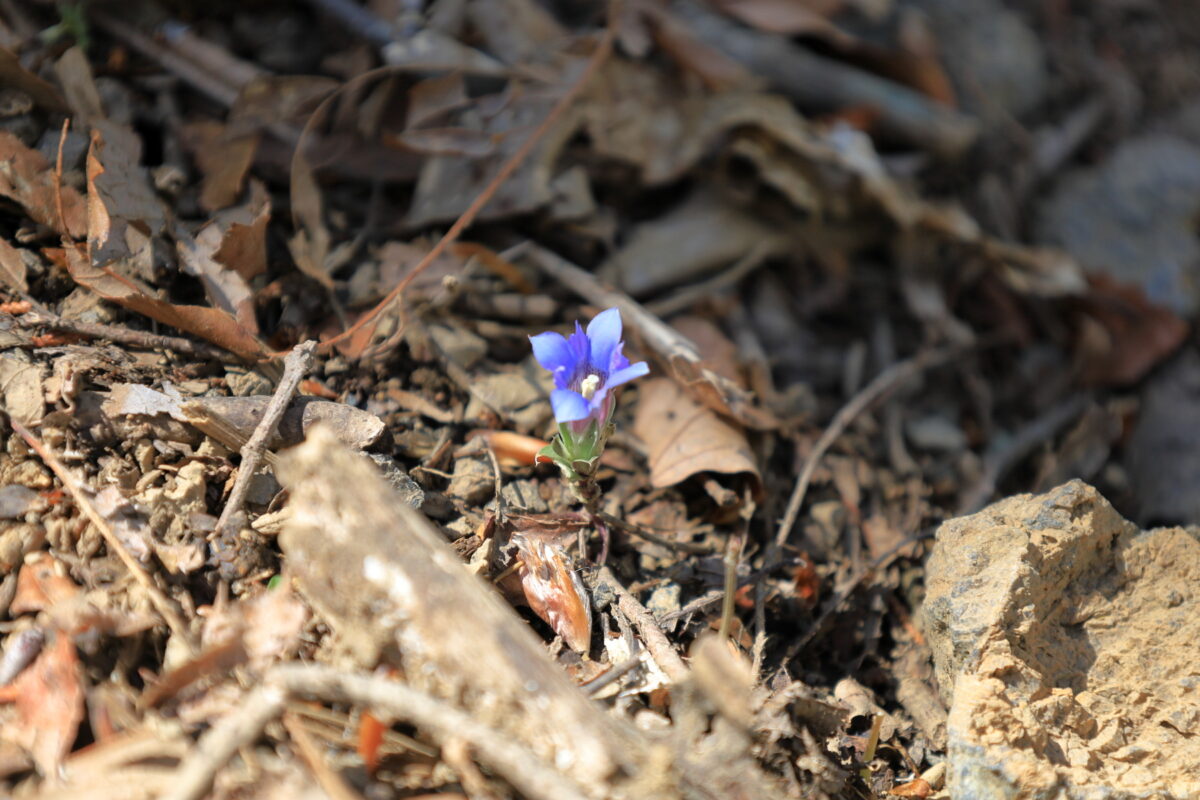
0, 131, 88, 239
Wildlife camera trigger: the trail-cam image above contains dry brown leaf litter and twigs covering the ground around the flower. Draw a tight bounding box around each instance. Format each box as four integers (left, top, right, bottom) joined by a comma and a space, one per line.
0, 0, 1200, 799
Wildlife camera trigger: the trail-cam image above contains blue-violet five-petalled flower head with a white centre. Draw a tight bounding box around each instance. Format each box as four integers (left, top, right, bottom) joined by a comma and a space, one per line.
529, 308, 650, 433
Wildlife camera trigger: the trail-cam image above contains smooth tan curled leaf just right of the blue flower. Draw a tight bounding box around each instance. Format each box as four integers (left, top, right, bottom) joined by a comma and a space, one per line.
634, 378, 760, 488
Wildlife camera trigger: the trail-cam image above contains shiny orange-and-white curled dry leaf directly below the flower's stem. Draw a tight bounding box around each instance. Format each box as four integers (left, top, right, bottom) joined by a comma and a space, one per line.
512, 534, 592, 652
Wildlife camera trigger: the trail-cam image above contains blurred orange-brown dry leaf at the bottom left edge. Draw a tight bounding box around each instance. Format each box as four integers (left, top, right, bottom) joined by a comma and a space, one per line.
0, 631, 84, 777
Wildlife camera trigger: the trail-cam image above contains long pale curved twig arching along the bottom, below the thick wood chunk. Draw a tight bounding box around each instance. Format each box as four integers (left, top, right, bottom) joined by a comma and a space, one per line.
270, 664, 587, 800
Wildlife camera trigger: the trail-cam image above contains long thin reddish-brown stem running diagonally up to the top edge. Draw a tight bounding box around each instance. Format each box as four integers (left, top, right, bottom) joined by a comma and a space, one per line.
320, 2, 620, 353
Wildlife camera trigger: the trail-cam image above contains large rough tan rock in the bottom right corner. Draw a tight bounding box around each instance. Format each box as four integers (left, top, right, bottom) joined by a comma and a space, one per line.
922, 481, 1200, 800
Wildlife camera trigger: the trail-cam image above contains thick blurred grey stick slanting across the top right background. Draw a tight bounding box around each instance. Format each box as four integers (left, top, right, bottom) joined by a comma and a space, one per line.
671, 0, 979, 156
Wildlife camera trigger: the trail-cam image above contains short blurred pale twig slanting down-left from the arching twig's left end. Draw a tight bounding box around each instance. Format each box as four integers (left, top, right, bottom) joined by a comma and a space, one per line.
160, 684, 288, 800
